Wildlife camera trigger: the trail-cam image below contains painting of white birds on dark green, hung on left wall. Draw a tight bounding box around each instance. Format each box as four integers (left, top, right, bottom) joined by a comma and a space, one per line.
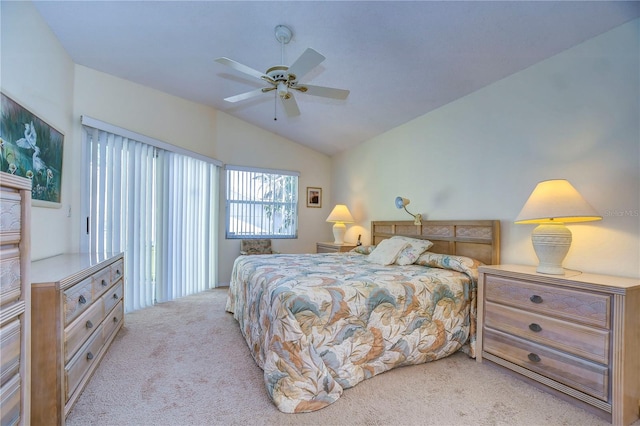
0, 93, 64, 208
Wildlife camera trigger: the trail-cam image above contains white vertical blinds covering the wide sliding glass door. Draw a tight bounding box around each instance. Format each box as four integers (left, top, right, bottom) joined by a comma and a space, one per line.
81, 120, 220, 312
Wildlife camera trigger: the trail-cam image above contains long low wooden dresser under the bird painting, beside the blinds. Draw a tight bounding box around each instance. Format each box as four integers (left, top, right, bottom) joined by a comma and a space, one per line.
31, 254, 124, 424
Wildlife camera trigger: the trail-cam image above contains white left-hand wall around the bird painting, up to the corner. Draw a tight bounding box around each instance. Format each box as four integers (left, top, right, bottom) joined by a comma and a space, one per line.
0, 1, 75, 259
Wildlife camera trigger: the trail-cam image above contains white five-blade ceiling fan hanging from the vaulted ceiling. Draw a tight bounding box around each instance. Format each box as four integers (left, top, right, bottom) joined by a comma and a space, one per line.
216, 25, 349, 117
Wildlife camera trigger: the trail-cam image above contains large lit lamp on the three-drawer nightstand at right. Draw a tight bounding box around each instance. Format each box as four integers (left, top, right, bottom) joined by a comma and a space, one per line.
515, 179, 602, 275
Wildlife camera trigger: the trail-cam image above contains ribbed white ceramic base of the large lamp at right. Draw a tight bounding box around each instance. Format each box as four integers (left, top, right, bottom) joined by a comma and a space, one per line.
531, 222, 572, 275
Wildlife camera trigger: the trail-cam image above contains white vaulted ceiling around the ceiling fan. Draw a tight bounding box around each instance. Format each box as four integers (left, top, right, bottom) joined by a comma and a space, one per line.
34, 0, 640, 155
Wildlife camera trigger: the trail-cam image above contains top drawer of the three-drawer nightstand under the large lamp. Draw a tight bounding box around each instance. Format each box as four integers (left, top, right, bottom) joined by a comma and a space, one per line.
484, 275, 611, 329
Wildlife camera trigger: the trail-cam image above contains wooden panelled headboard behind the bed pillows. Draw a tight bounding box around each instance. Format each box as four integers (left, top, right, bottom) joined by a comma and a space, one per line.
371, 220, 500, 265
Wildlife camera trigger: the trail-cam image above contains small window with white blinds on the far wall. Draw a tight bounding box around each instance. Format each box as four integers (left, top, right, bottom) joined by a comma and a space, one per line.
225, 165, 300, 239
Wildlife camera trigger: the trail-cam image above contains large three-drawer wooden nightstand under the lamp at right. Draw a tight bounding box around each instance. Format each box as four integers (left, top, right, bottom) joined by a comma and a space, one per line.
477, 265, 640, 425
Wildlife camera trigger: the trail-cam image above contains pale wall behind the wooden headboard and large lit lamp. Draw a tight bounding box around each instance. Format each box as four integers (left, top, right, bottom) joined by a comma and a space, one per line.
332, 20, 640, 277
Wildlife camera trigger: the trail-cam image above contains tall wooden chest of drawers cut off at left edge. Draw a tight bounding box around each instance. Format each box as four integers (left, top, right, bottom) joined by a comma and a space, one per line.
0, 172, 31, 426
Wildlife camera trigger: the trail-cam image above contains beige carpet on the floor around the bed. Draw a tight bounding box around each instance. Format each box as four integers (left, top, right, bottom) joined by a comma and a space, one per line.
67, 289, 640, 426
